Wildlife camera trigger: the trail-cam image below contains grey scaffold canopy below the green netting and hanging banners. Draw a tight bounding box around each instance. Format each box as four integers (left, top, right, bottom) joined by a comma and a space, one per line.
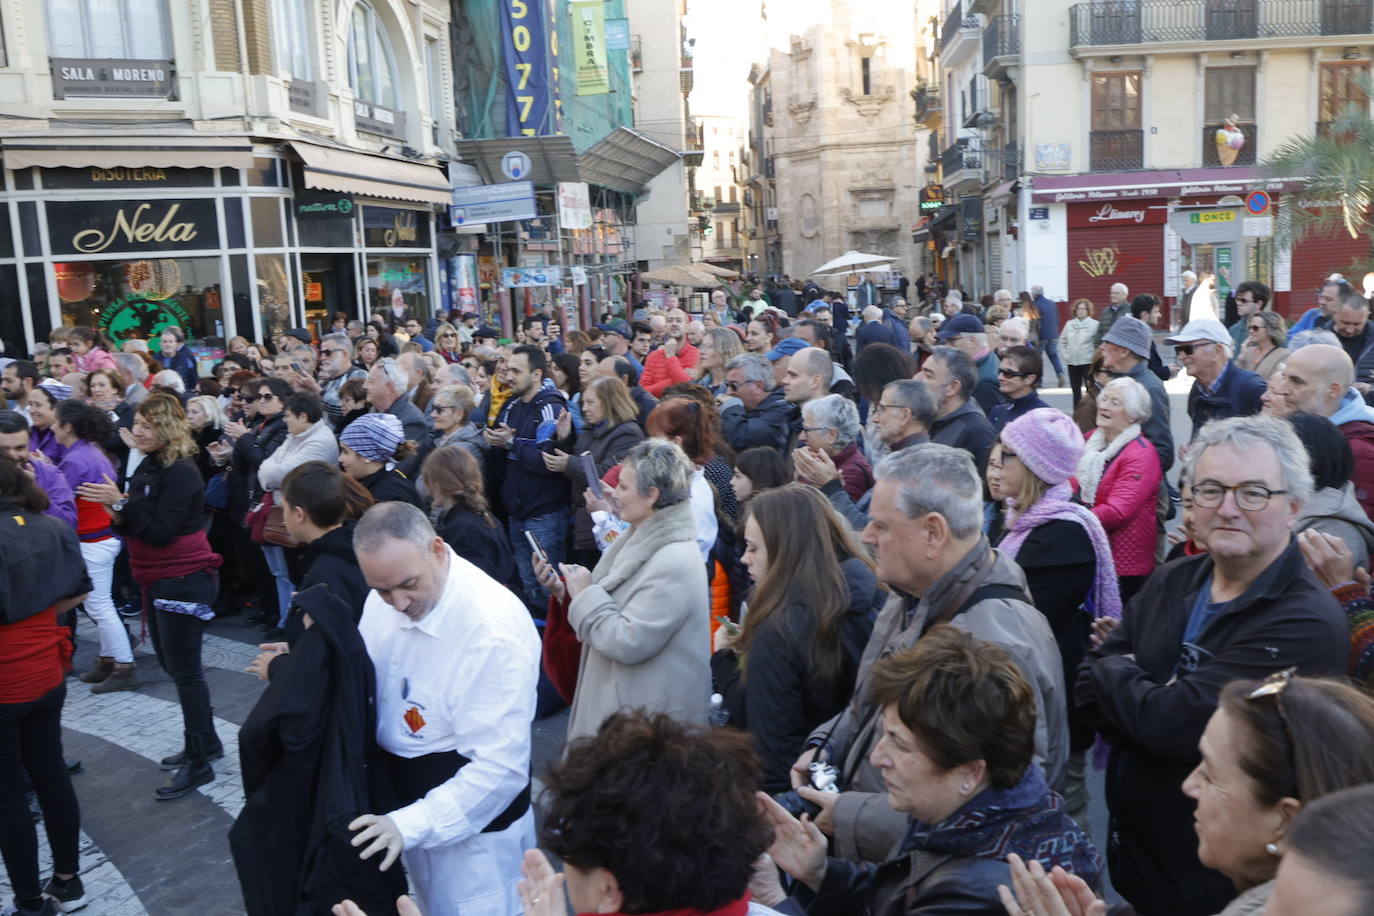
458, 128, 680, 194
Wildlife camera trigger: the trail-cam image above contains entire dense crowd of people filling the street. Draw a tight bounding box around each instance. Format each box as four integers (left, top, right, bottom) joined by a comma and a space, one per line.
0, 283, 1374, 916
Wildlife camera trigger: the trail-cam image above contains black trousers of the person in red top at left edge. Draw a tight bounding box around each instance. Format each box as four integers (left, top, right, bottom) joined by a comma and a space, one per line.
0, 683, 81, 901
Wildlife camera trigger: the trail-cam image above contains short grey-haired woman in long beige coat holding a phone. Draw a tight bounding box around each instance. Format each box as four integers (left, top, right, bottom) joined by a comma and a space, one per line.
533, 439, 710, 740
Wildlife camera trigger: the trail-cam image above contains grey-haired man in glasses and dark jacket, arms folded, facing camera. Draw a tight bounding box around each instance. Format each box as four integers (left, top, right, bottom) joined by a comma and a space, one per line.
1074, 416, 1349, 916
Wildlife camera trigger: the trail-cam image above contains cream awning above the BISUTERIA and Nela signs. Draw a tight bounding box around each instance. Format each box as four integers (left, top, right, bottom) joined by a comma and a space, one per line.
4, 136, 253, 169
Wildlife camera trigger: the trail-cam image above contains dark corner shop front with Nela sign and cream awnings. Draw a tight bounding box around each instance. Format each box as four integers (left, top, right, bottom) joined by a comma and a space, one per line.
0, 139, 447, 360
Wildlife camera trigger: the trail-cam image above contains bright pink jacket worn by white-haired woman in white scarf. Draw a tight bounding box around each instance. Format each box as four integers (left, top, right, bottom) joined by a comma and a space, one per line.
1090, 434, 1162, 575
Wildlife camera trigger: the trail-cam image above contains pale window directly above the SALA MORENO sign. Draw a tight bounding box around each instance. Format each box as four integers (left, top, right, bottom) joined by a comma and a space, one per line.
47, 0, 172, 60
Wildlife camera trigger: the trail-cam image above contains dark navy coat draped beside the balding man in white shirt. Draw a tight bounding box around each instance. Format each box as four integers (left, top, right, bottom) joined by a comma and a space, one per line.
229, 585, 405, 916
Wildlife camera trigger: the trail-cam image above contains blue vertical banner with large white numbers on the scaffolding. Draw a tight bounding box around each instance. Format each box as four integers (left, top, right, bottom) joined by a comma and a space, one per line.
500, 0, 556, 137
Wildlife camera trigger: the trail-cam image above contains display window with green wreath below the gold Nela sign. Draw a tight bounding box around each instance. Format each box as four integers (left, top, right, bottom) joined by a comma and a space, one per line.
52, 258, 224, 342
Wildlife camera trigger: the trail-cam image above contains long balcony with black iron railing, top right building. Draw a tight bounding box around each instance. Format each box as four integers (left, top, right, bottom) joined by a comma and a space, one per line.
1069, 0, 1374, 48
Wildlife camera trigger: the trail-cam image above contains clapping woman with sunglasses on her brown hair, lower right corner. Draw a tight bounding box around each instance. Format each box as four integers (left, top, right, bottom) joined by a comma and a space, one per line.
1002, 669, 1374, 916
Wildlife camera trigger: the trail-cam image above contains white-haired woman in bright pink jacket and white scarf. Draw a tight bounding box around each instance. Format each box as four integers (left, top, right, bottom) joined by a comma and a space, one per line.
1076, 379, 1164, 604
